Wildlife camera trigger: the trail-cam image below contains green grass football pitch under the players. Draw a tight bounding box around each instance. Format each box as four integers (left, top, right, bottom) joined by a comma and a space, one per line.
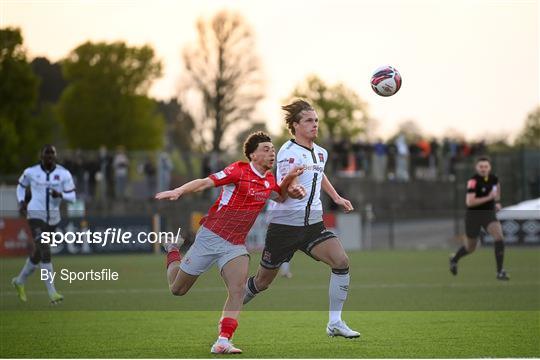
0, 247, 540, 358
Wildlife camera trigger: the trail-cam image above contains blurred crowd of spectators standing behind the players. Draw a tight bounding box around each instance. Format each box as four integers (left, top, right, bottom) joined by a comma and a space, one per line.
62, 135, 486, 201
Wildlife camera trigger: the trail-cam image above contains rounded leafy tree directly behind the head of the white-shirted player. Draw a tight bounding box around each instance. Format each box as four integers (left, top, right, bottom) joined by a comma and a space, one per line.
292, 75, 373, 141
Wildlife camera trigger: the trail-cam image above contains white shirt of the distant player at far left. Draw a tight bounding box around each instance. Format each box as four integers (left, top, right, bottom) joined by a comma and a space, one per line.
17, 164, 75, 225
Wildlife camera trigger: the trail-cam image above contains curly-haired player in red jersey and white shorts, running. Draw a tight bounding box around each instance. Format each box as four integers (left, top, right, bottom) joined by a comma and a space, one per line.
156, 132, 305, 354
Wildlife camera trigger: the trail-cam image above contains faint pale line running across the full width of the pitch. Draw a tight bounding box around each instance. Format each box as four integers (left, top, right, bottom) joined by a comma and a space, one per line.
0, 281, 540, 296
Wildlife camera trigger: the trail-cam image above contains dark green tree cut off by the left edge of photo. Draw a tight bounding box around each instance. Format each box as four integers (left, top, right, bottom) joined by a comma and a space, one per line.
0, 28, 39, 174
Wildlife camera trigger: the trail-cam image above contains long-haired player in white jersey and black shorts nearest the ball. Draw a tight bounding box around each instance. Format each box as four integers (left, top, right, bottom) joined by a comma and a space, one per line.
244, 100, 360, 338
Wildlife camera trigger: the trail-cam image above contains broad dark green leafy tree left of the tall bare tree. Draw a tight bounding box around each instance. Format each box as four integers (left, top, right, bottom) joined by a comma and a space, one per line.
58, 42, 164, 150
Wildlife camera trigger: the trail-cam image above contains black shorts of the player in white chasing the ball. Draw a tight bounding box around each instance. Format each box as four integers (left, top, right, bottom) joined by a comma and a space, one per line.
261, 221, 336, 269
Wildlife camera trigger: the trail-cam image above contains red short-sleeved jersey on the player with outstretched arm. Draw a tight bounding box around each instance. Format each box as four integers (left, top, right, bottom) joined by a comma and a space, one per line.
201, 161, 281, 244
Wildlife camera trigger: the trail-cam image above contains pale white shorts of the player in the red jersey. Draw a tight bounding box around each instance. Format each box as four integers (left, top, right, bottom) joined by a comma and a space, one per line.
180, 226, 249, 276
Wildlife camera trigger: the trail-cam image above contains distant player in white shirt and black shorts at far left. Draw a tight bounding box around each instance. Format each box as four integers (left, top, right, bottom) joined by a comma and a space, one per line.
11, 145, 75, 304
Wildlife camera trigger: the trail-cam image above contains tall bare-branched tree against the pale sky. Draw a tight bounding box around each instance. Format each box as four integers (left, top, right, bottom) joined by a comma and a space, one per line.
183, 11, 263, 152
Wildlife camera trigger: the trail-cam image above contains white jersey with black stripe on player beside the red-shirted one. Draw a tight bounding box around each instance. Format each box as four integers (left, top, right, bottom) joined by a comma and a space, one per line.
269, 140, 328, 226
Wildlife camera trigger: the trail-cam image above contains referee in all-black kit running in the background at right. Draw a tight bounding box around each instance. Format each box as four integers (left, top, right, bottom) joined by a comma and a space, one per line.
450, 157, 510, 280
